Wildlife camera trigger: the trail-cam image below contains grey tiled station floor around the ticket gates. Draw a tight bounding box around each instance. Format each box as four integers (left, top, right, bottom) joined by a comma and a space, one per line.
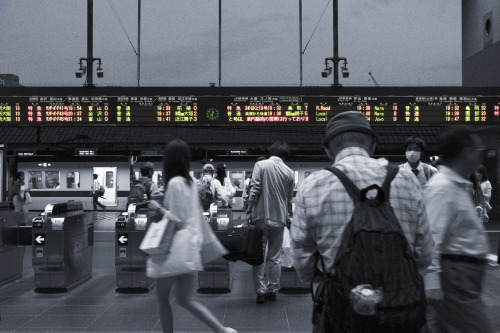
0, 212, 500, 332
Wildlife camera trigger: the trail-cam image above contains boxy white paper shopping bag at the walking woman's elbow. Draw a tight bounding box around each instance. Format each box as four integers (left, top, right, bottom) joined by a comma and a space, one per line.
139, 214, 180, 255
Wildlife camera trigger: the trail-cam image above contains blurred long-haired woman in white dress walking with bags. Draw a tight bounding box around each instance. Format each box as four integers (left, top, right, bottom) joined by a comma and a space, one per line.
148, 140, 237, 333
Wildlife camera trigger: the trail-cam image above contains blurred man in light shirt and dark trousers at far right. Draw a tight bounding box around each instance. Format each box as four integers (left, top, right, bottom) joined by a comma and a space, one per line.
424, 125, 491, 333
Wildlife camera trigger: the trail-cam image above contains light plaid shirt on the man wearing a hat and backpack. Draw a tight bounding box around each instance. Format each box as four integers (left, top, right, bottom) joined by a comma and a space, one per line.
290, 147, 433, 281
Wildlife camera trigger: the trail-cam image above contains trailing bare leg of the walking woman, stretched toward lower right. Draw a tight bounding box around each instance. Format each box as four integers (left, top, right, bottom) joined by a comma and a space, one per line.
175, 273, 228, 332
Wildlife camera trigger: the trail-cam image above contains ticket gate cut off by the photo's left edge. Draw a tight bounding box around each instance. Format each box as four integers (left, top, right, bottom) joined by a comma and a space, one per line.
0, 202, 24, 286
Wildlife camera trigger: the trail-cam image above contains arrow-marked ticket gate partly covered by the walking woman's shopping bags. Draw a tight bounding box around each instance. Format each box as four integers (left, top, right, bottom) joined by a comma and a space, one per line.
115, 203, 162, 293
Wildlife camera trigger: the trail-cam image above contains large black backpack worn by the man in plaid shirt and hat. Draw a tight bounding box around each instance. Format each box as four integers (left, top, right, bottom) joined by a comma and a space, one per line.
313, 165, 426, 333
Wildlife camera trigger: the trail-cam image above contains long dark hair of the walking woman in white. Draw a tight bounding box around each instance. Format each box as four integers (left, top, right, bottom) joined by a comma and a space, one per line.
163, 139, 193, 188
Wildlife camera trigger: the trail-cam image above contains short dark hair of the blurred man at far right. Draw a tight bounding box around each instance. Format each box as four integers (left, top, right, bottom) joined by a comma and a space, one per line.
439, 125, 474, 165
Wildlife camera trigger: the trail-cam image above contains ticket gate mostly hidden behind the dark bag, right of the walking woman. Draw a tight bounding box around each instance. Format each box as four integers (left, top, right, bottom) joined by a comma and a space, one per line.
198, 205, 233, 294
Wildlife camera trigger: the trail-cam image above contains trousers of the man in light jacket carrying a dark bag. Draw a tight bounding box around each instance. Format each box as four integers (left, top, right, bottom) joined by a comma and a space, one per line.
252, 220, 285, 294
